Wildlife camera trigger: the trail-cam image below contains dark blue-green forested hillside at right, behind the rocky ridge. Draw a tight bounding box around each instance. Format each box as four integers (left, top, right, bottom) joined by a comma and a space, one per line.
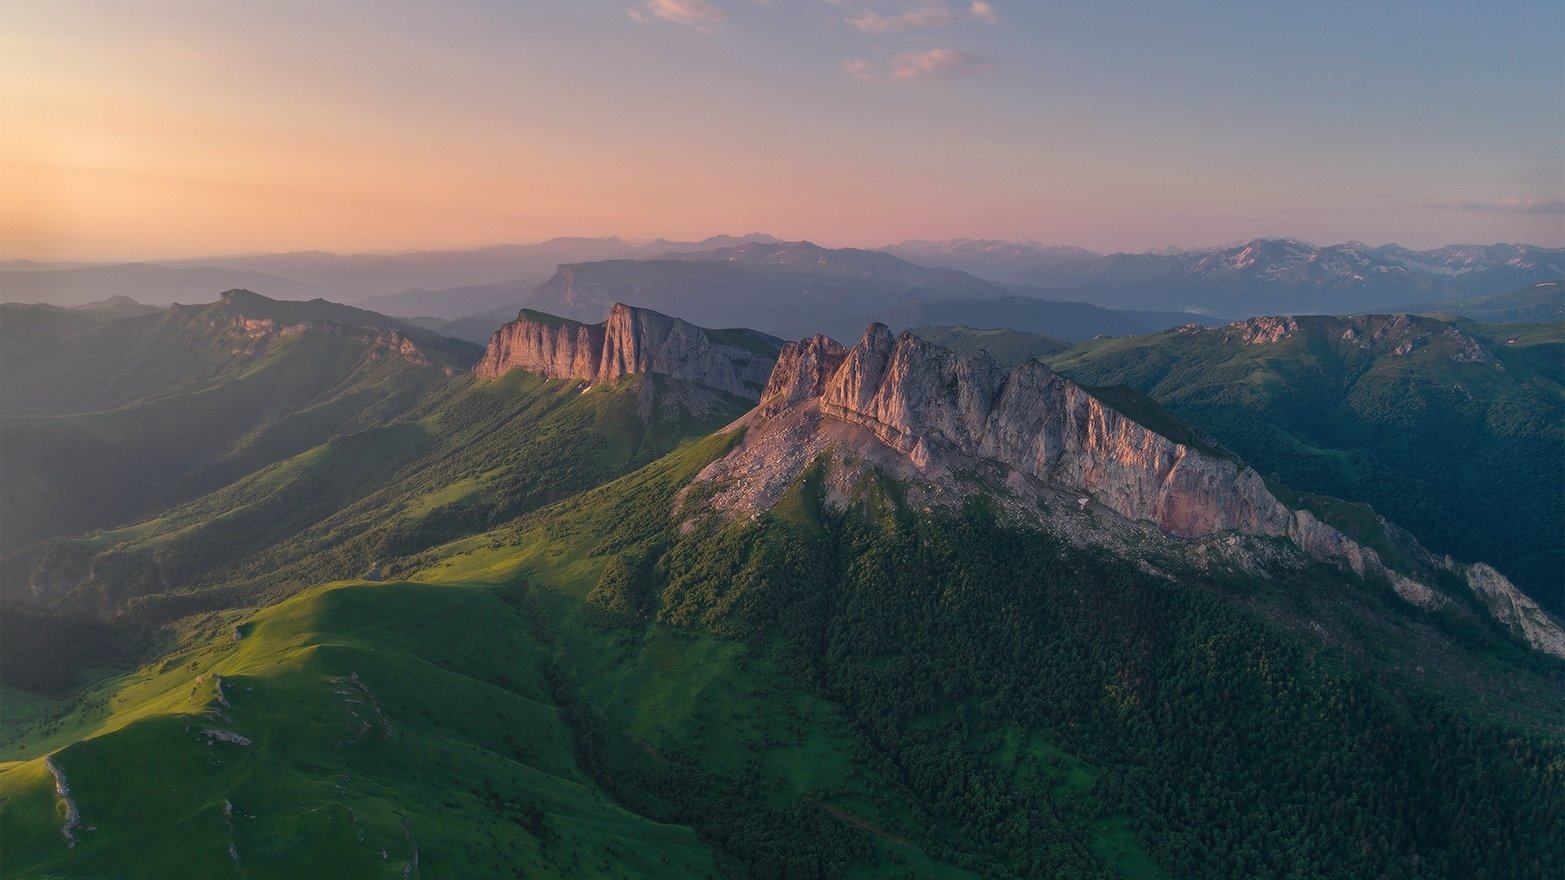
1049, 315, 1565, 614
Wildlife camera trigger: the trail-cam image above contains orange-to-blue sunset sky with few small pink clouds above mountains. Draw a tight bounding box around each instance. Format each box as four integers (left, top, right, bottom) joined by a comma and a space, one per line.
0, 0, 1565, 260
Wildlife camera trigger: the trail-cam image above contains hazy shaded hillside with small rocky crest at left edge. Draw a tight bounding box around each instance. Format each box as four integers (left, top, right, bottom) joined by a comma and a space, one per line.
0, 291, 476, 553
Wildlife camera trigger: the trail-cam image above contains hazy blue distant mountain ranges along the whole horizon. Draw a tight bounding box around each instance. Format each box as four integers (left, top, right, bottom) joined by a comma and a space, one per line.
0, 233, 1565, 331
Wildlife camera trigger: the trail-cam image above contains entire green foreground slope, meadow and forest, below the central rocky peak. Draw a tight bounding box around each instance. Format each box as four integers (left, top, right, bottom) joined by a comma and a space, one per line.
0, 422, 1565, 877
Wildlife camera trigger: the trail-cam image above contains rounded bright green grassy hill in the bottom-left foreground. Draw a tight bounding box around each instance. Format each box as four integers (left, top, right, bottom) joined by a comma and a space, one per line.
0, 584, 714, 877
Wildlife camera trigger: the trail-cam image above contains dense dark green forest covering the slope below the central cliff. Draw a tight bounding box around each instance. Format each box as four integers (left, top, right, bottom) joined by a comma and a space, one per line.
572, 472, 1565, 878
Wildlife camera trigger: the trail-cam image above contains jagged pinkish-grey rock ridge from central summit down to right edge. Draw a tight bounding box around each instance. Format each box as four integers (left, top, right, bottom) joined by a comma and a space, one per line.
711, 324, 1565, 658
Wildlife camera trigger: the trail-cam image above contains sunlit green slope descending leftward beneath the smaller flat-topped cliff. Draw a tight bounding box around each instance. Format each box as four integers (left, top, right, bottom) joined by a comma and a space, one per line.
9, 371, 750, 619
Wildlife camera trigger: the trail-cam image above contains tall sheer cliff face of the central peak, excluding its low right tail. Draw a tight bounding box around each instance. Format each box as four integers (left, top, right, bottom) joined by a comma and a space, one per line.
795, 324, 1291, 537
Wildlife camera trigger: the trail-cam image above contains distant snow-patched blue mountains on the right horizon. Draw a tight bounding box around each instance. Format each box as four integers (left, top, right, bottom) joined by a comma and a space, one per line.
1008, 240, 1565, 318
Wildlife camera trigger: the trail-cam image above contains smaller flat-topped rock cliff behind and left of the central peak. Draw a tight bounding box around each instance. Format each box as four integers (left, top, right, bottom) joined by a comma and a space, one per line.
473, 304, 781, 399
